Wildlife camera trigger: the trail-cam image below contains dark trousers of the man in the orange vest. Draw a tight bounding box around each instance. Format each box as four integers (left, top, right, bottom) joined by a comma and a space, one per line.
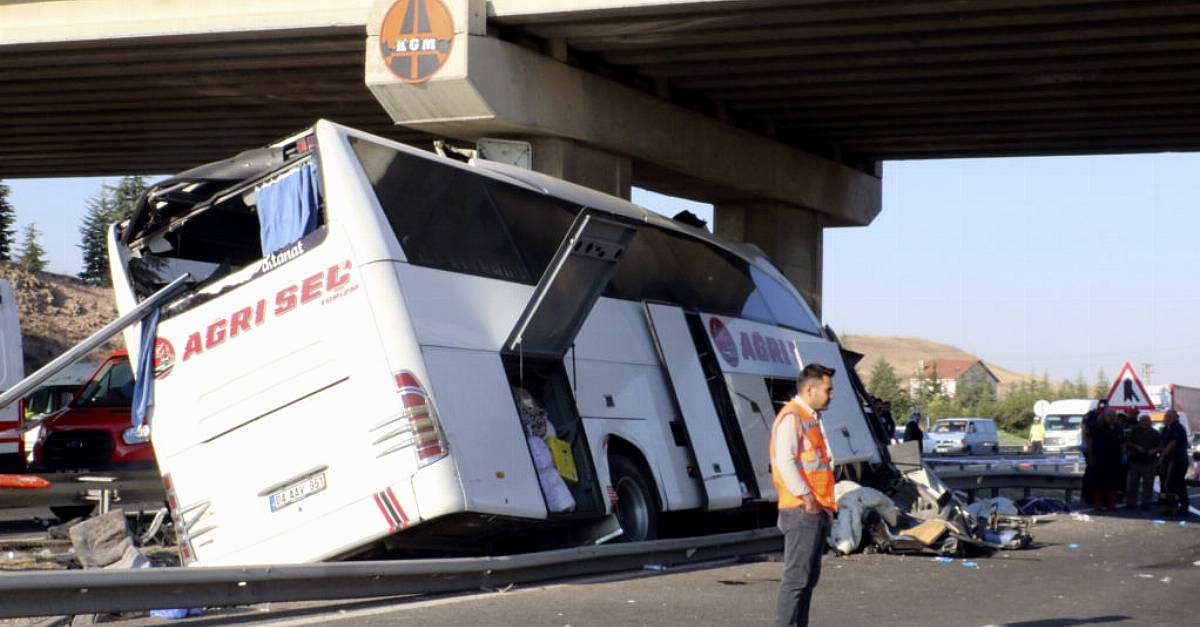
775, 509, 829, 626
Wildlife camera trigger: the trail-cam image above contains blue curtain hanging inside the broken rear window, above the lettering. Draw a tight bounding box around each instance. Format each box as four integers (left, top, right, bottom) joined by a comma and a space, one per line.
258, 163, 319, 257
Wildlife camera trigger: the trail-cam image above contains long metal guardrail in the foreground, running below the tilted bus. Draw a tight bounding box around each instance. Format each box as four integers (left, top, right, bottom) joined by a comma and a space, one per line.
0, 529, 782, 617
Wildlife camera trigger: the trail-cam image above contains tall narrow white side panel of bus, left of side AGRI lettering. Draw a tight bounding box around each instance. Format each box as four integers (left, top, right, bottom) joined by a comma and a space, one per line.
646, 303, 742, 509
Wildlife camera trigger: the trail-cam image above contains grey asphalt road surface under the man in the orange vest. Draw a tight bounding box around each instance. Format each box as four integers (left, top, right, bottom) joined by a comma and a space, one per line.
30, 497, 1200, 627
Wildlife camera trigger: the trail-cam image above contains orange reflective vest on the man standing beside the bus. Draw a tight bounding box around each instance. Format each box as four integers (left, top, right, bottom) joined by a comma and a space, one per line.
769, 399, 838, 512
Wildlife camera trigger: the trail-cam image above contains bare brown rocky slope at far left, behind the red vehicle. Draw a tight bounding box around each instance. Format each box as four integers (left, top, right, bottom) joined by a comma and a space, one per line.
0, 263, 125, 374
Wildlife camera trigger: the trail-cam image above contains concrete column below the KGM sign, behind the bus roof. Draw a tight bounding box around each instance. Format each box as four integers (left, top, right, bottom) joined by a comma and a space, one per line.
522, 137, 634, 201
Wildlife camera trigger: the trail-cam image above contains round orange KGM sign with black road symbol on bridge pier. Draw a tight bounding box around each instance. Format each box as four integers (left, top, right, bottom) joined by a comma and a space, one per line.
379, 0, 454, 83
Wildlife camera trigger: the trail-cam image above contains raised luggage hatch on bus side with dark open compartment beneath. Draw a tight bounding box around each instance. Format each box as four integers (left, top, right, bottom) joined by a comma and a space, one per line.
503, 210, 637, 515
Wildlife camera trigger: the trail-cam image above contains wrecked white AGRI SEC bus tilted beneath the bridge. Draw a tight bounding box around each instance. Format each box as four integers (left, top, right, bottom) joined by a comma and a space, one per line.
109, 121, 880, 565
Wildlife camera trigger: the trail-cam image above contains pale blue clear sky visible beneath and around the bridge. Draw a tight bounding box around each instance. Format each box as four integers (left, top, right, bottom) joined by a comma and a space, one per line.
6, 154, 1200, 386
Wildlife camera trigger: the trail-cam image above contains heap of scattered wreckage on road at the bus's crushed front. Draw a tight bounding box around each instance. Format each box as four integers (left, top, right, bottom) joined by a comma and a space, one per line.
828, 442, 1033, 556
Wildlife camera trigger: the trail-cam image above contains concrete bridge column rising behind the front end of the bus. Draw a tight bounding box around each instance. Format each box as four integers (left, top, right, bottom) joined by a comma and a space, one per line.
713, 201, 824, 316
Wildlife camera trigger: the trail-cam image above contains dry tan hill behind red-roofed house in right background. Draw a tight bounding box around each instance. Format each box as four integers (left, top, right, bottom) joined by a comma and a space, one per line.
839, 335, 1030, 394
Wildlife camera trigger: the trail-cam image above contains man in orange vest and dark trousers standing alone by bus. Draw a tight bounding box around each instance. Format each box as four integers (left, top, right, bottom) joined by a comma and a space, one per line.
769, 364, 838, 626
